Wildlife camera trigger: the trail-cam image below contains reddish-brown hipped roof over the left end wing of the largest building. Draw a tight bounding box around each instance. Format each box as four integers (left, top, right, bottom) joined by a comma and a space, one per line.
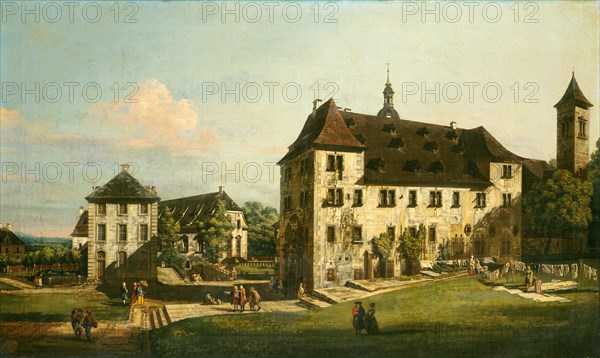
279, 99, 364, 164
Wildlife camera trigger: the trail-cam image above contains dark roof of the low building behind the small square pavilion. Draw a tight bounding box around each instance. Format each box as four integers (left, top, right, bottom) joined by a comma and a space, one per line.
158, 192, 245, 233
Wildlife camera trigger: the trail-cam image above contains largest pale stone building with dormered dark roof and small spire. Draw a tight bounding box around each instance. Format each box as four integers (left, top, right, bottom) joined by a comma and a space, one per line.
278, 76, 572, 292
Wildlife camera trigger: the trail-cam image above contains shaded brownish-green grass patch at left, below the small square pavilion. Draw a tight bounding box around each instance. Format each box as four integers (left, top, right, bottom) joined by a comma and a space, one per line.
0, 289, 129, 322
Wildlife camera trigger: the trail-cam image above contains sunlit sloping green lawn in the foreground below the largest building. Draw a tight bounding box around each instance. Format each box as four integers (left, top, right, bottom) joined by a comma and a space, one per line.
151, 277, 600, 357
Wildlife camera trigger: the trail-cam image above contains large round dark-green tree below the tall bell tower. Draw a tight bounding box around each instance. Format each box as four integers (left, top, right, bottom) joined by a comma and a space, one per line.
524, 170, 593, 237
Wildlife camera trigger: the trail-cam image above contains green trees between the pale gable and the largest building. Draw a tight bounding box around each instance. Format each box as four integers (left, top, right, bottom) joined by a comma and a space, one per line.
242, 201, 279, 256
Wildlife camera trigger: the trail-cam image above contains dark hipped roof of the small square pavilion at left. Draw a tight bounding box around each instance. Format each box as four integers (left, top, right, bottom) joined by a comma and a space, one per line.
85, 170, 160, 203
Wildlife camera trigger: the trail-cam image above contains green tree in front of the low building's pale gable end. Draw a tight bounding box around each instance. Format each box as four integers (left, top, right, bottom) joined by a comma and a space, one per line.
196, 200, 235, 263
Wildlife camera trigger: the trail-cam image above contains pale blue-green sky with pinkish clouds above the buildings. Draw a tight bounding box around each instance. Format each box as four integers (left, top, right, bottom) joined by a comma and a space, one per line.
0, 1, 600, 236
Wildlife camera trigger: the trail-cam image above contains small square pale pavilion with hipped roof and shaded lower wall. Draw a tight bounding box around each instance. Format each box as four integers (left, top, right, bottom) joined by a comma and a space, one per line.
74, 165, 160, 282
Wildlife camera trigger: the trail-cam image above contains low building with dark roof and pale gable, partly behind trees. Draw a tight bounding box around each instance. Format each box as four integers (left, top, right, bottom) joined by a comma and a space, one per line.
159, 186, 248, 259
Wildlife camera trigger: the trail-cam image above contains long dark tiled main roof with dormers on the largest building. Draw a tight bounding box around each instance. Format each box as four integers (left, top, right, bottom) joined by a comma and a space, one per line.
342, 112, 510, 188
